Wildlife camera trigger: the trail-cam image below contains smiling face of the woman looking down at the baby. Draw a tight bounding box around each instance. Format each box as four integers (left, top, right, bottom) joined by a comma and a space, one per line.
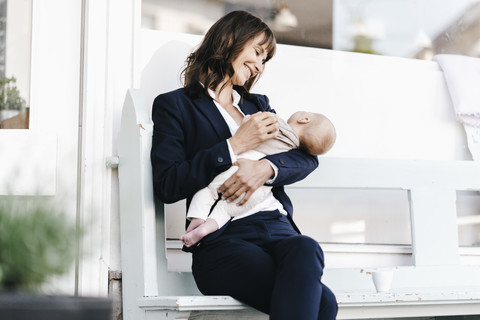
232, 33, 268, 86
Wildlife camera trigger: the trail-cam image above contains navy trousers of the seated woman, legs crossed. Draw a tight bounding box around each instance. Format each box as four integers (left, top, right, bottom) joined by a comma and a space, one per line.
192, 211, 338, 320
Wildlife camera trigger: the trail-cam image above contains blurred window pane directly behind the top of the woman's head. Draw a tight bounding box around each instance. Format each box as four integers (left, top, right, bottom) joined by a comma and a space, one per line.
142, 0, 333, 48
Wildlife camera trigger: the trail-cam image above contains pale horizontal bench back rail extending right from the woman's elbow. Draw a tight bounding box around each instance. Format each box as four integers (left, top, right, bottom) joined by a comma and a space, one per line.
289, 157, 480, 190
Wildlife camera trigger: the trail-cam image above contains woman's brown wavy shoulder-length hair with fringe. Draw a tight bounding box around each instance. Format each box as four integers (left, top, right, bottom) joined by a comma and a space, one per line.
182, 11, 276, 96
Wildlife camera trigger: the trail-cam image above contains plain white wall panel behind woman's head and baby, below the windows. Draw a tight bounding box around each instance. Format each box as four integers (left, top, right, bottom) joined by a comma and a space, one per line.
139, 31, 471, 160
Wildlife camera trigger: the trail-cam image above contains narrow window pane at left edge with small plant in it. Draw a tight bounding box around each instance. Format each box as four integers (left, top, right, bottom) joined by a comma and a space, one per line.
0, 0, 32, 129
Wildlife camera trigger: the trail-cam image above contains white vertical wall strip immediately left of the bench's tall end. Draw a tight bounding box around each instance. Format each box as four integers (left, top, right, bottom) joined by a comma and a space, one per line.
80, 0, 140, 295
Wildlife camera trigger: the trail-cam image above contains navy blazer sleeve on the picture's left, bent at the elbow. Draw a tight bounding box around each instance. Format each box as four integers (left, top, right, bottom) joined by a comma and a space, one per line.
151, 94, 231, 203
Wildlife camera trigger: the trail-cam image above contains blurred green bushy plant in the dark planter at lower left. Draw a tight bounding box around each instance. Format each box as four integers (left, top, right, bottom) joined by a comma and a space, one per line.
0, 198, 79, 291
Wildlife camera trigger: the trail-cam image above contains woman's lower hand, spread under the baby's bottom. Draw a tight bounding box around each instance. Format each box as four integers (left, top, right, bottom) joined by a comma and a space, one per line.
218, 159, 274, 205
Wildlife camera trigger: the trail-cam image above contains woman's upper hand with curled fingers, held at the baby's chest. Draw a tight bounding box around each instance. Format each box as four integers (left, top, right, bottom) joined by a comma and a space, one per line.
228, 111, 279, 155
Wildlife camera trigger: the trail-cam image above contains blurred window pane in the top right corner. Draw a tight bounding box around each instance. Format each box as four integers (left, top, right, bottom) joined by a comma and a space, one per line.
333, 0, 480, 60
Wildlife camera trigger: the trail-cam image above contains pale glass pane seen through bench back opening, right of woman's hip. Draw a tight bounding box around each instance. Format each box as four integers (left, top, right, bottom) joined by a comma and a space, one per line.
287, 188, 412, 245
